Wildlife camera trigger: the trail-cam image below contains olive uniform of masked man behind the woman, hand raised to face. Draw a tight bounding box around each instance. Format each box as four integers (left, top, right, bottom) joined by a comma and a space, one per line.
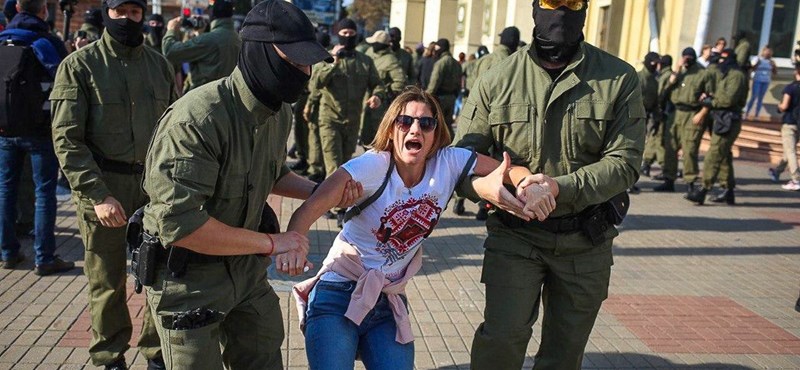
311, 51, 385, 176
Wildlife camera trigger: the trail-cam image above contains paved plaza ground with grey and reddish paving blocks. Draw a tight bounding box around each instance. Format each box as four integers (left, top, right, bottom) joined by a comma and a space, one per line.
0, 161, 800, 370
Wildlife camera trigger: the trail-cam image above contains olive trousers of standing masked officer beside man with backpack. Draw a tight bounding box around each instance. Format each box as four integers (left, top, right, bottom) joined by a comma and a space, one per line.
74, 172, 161, 366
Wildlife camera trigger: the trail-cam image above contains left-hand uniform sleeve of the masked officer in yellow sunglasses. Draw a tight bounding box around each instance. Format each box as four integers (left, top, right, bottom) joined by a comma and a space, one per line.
453, 76, 494, 201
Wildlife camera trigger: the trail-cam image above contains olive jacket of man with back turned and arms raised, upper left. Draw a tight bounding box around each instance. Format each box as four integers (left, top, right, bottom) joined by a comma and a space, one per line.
161, 18, 242, 91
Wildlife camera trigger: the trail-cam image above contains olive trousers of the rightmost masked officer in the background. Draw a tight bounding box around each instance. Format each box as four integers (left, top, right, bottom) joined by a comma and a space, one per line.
703, 121, 742, 189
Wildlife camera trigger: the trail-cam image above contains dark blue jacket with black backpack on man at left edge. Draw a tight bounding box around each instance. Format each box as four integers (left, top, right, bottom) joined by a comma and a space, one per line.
0, 28, 61, 137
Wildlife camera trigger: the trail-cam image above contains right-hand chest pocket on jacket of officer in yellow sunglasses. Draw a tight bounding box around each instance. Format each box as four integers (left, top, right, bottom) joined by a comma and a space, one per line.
567, 101, 614, 159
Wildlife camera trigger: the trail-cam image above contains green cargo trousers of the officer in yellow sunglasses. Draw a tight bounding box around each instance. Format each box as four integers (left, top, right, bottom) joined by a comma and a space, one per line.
471, 221, 617, 370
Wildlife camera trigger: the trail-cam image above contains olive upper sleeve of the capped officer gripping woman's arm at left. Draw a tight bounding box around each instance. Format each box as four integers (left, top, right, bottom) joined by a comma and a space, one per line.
144, 112, 221, 245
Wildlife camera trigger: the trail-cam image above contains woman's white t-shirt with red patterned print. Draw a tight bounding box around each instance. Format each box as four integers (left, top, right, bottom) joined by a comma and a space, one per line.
320, 147, 475, 281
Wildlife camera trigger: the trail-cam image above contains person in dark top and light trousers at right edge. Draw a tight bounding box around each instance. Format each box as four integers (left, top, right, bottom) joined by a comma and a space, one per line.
769, 66, 800, 191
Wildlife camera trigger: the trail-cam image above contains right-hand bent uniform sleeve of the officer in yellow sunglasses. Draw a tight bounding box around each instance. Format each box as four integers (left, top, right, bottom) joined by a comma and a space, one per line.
554, 71, 645, 210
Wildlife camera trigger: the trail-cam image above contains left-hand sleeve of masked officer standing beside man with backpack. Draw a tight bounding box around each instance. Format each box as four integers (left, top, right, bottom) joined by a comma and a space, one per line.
50, 59, 111, 204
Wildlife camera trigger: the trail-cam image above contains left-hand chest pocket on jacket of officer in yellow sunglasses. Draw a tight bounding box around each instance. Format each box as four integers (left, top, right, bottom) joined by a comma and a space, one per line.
488, 104, 536, 164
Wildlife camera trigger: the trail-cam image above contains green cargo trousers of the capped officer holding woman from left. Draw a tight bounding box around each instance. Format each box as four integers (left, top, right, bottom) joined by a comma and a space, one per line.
147, 255, 284, 370
